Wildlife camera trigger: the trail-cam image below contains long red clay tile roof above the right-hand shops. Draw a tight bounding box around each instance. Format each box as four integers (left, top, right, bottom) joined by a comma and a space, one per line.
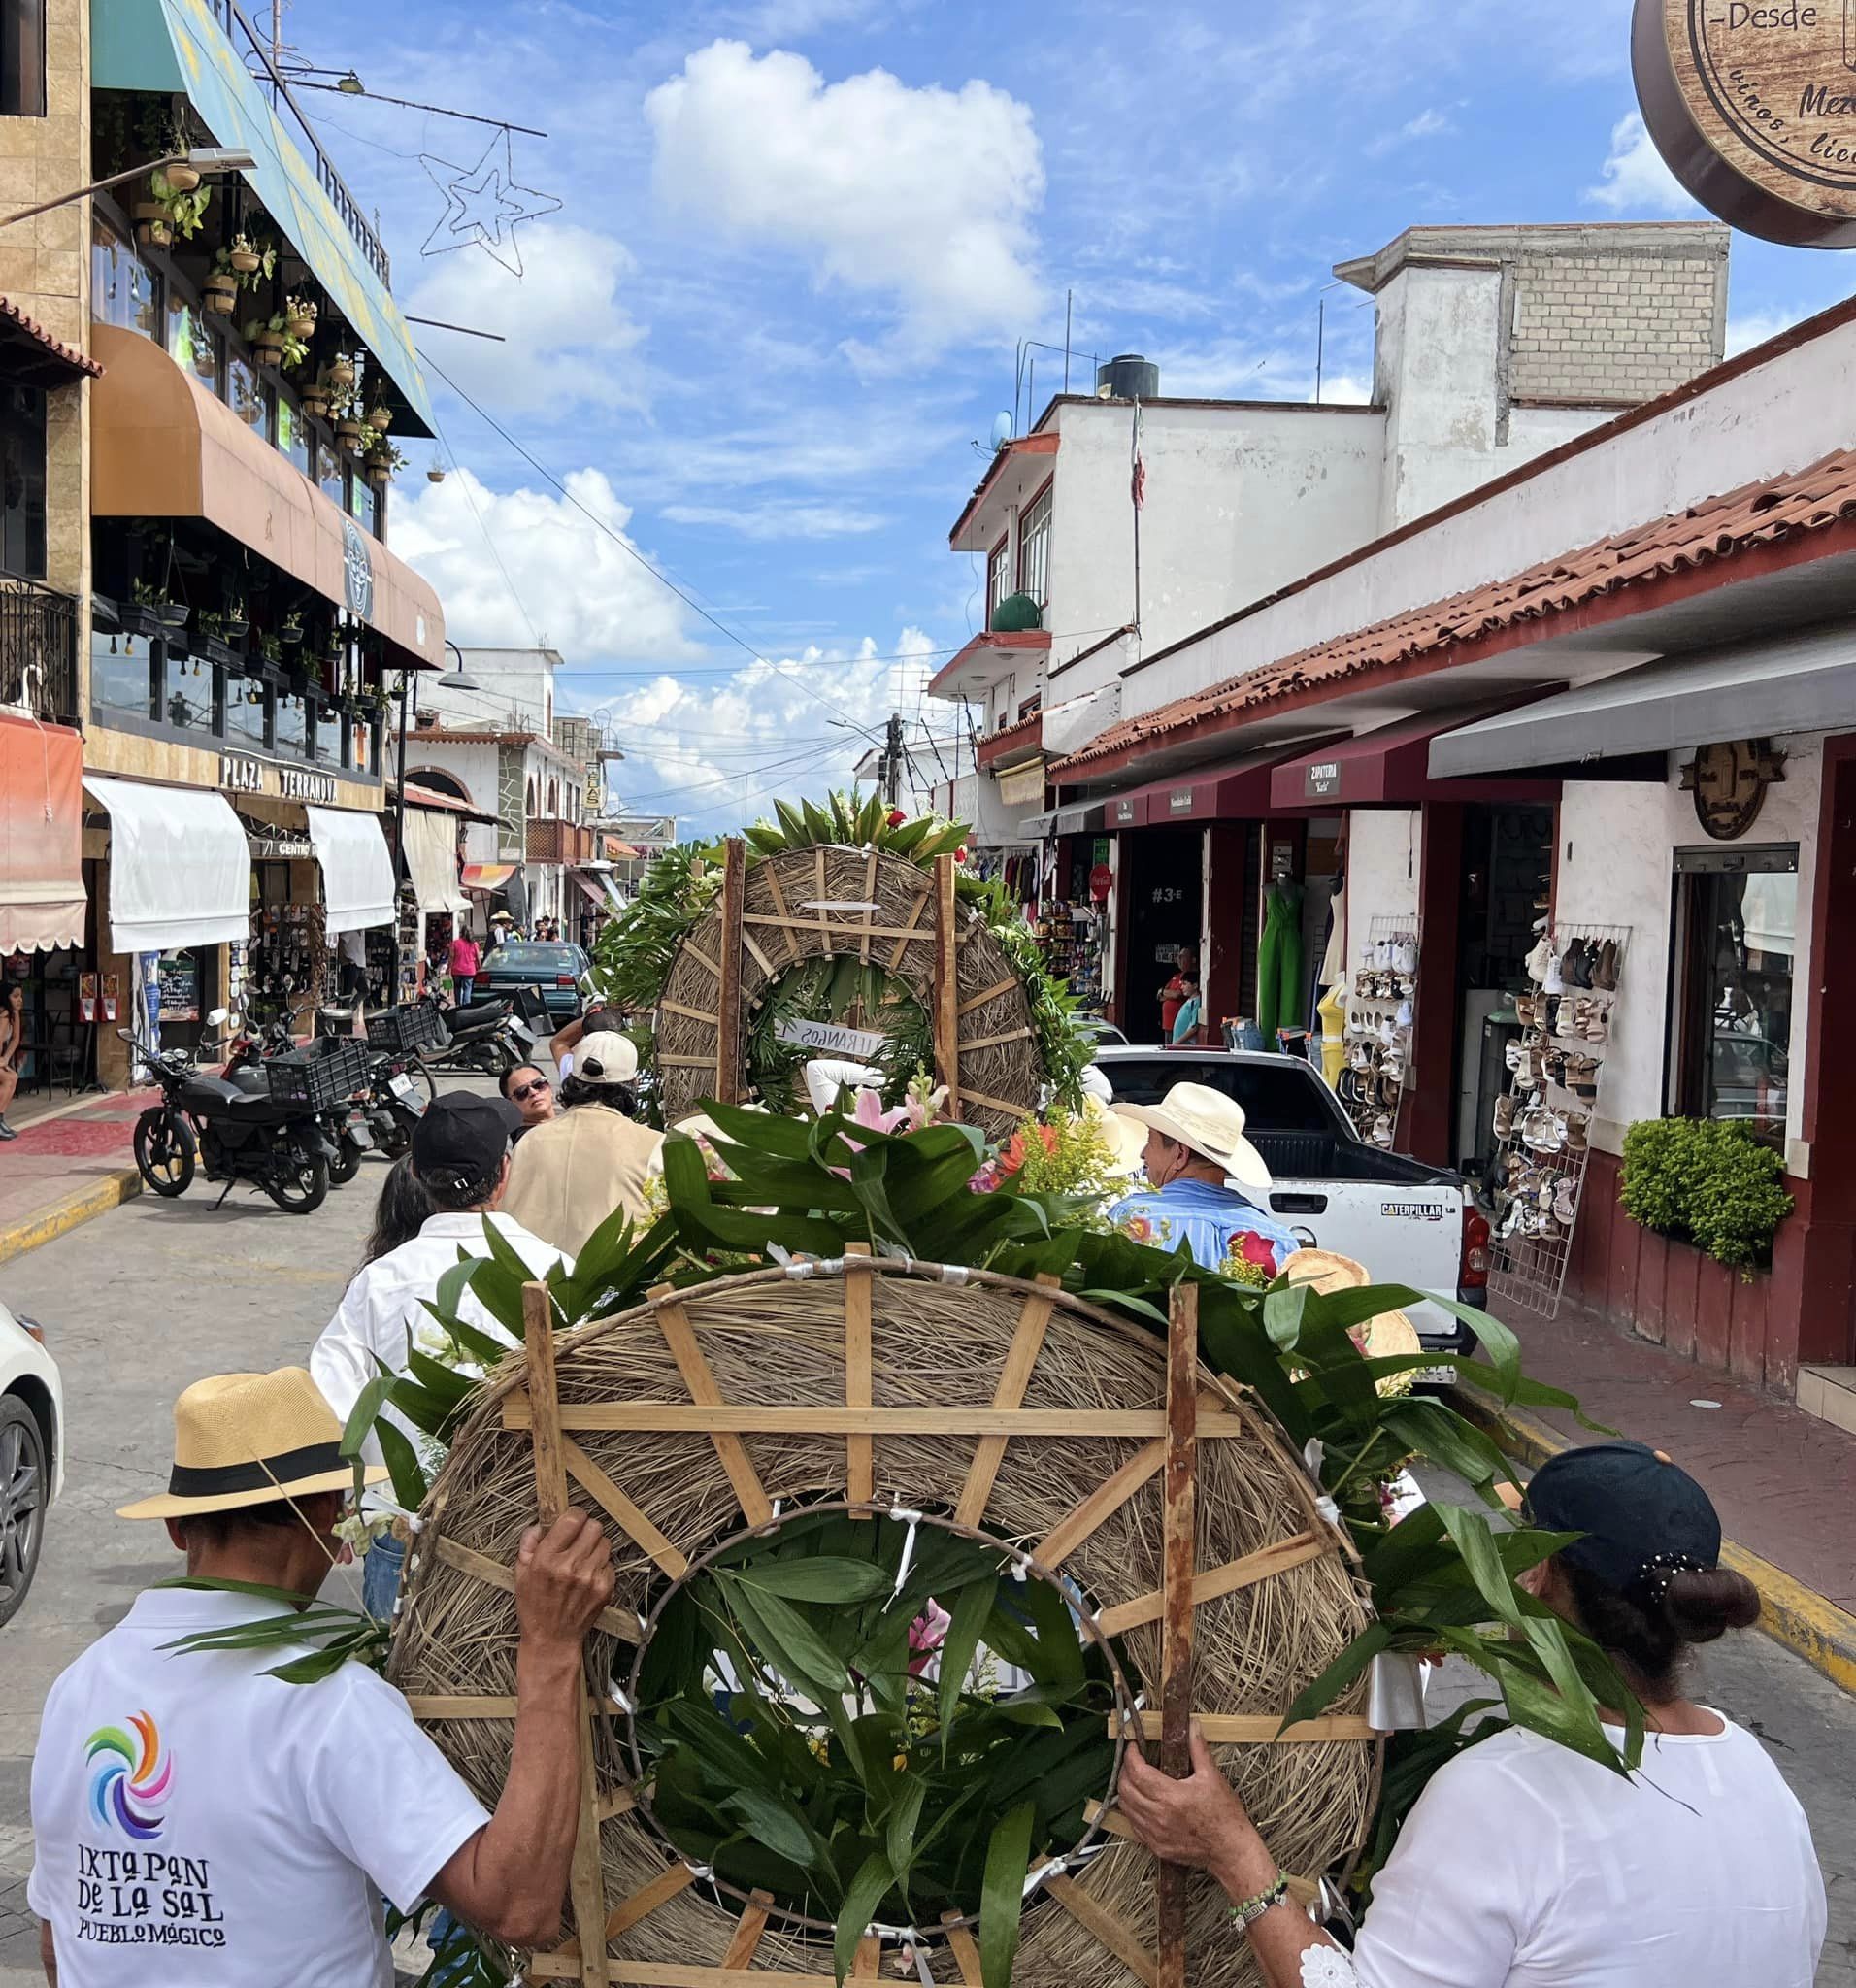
1051, 449, 1856, 781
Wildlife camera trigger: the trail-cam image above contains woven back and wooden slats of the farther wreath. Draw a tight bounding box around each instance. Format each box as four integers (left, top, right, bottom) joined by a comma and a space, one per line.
653, 841, 1042, 1137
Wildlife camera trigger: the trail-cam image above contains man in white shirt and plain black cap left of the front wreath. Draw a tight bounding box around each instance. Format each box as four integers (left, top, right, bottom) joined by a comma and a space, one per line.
310, 1091, 573, 1616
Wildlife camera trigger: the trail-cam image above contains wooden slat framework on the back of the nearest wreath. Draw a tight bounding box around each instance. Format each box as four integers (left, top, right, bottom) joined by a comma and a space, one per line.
393, 1244, 1379, 1988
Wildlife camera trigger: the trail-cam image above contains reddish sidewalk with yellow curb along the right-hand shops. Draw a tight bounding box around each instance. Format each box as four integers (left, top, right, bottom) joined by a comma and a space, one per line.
1463, 1304, 1856, 1690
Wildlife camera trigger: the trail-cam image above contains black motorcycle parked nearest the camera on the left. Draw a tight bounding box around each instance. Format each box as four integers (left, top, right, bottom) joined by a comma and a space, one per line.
117, 1008, 340, 1214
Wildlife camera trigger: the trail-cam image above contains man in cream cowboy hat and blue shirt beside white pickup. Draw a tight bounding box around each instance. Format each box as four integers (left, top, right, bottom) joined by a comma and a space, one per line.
1109, 1083, 1298, 1282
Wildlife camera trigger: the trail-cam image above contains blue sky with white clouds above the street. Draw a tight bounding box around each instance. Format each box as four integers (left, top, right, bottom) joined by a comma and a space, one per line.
284, 0, 1850, 829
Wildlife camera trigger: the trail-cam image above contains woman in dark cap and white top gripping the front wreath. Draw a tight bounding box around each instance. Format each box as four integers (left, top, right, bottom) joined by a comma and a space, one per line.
1116, 1443, 1826, 1988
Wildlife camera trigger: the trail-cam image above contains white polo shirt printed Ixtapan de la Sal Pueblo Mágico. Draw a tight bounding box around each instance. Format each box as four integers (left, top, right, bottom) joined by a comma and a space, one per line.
26, 1588, 489, 1988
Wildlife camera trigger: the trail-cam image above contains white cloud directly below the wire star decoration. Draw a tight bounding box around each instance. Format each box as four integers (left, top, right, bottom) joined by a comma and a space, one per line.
406, 222, 646, 415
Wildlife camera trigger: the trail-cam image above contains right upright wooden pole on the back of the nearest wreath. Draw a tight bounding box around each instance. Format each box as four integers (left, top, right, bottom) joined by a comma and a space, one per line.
1154, 1278, 1198, 1988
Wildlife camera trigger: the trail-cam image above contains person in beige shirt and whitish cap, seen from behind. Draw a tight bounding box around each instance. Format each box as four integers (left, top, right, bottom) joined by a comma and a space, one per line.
507, 1030, 664, 1256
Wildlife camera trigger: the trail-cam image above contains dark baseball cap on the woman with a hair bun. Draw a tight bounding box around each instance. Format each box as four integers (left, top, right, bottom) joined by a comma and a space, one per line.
1526, 1443, 1721, 1594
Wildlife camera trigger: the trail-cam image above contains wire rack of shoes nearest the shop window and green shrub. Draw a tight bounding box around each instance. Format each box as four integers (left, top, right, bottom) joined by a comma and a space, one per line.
1488, 924, 1630, 1318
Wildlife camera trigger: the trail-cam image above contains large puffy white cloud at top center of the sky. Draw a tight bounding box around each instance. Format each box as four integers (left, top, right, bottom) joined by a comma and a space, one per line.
644, 42, 1044, 344
